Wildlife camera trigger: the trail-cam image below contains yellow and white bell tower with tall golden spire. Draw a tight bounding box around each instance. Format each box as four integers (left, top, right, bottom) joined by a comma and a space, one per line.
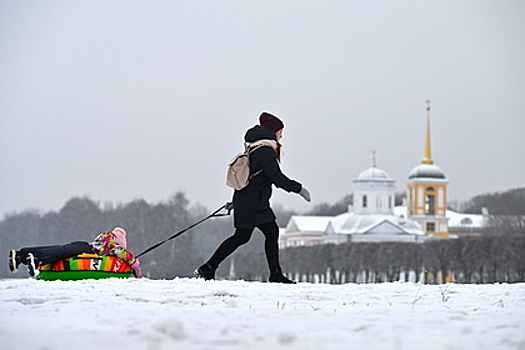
407, 101, 448, 238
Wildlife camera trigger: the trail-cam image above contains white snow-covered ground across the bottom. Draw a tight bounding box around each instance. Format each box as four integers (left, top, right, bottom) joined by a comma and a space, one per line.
0, 279, 525, 350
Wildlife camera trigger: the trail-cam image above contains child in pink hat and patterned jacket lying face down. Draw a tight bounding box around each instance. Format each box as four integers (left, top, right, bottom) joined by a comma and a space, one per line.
9, 227, 142, 278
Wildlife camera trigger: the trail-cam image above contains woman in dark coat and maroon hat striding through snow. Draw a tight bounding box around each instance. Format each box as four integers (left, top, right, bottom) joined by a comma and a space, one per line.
195, 112, 310, 283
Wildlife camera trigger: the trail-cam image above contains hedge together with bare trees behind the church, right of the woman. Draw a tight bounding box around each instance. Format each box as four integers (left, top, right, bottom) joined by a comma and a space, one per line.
226, 188, 525, 283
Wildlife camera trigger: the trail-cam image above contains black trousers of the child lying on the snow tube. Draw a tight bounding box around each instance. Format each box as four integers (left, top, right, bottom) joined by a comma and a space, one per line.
18, 241, 93, 265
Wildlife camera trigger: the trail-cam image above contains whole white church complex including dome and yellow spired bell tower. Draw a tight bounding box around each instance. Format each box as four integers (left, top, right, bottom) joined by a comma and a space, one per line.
279, 102, 485, 248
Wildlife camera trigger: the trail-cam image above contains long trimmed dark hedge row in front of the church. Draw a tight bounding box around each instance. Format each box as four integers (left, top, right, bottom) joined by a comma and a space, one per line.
229, 234, 525, 284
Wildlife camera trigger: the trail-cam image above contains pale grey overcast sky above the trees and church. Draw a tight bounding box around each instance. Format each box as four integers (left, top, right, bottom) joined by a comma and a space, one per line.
0, 0, 525, 218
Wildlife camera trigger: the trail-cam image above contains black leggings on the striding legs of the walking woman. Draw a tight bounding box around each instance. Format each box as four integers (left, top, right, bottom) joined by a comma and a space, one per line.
208, 221, 281, 272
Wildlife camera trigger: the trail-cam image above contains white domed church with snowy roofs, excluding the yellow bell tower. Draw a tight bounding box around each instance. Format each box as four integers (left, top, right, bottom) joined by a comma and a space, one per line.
280, 161, 434, 248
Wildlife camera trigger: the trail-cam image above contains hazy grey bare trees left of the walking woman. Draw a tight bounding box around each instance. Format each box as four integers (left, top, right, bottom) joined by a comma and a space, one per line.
0, 192, 232, 278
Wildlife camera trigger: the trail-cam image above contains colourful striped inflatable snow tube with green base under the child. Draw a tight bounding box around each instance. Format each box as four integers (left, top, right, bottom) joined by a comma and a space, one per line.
35, 254, 132, 281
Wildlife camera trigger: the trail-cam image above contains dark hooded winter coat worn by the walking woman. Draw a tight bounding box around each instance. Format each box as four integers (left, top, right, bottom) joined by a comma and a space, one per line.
233, 125, 302, 229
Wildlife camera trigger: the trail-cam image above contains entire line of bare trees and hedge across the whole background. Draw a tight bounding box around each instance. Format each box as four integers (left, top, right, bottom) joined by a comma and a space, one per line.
0, 189, 525, 283
